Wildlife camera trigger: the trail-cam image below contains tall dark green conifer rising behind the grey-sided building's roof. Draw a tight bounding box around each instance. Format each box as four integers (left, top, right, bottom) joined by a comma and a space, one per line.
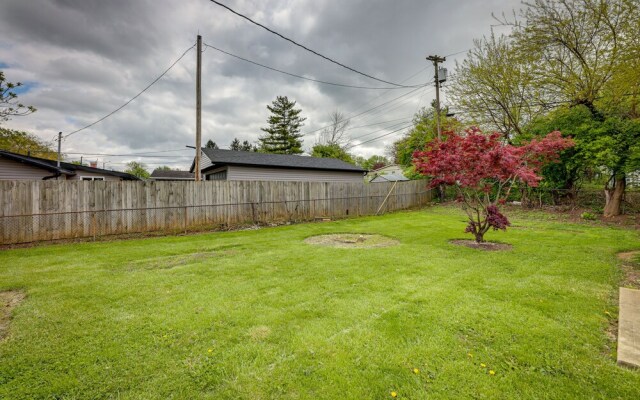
259, 96, 306, 154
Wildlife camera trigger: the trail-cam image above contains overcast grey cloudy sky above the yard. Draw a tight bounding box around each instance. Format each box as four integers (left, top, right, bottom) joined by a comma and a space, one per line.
0, 0, 520, 169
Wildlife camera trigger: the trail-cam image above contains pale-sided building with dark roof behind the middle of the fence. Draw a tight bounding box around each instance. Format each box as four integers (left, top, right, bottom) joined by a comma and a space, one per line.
191, 148, 365, 182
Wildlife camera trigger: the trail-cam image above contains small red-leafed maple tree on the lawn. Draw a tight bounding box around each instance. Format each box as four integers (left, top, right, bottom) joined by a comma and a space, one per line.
413, 127, 574, 243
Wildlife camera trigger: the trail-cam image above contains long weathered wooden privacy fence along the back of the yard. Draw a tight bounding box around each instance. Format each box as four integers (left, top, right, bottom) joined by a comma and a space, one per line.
0, 181, 431, 244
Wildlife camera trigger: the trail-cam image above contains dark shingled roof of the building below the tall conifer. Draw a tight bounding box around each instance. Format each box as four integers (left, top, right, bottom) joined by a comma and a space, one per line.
198, 148, 364, 172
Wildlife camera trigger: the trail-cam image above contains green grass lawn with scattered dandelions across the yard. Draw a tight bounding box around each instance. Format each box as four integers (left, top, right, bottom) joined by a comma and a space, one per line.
0, 207, 640, 399
